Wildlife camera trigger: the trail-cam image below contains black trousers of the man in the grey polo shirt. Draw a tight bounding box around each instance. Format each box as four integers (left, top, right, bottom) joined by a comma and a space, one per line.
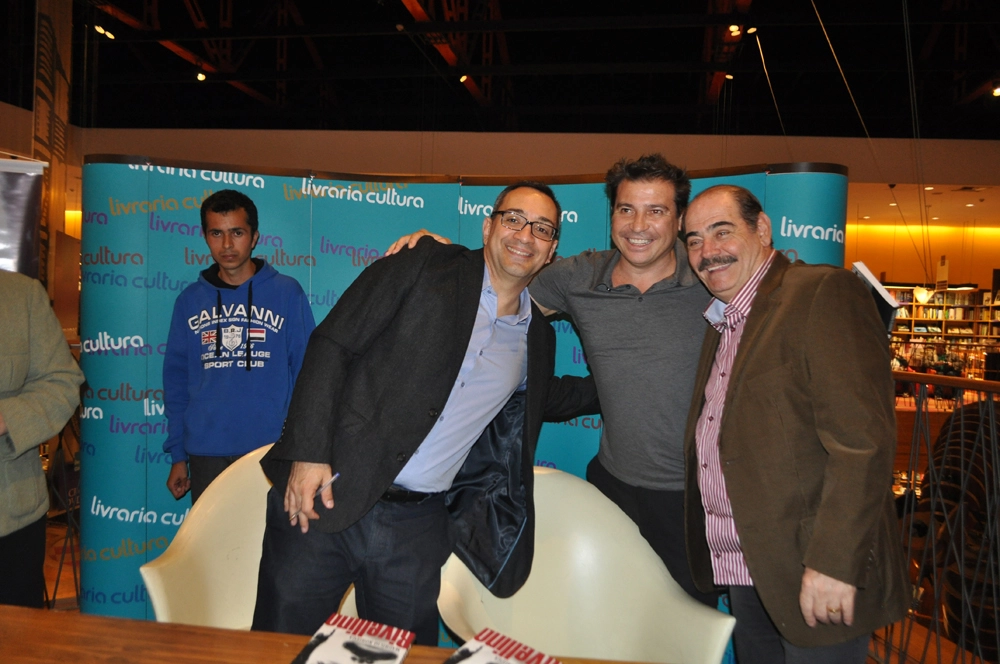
587, 457, 719, 609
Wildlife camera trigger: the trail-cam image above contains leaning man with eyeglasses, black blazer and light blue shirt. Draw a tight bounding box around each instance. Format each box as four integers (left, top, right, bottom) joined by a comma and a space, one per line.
253, 182, 598, 645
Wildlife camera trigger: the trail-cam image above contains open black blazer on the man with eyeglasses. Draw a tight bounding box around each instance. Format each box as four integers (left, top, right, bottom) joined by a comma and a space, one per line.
261, 238, 599, 596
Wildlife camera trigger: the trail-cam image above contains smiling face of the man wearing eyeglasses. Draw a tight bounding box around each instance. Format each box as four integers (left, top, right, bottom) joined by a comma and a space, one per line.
483, 187, 559, 285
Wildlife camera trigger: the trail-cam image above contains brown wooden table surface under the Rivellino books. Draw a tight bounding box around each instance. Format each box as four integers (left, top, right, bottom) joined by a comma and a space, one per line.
0, 605, 608, 664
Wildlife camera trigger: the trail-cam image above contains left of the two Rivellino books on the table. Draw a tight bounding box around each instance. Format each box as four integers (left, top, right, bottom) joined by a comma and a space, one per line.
292, 613, 415, 664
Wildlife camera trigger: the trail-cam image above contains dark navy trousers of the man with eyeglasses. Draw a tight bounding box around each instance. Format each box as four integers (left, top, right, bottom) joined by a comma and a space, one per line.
253, 489, 452, 645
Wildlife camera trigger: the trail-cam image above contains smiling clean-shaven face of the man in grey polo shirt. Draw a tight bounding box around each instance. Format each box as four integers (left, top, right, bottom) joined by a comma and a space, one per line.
611, 180, 680, 278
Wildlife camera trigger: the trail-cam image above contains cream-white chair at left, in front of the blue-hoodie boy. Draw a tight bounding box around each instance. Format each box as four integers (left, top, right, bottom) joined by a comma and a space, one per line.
139, 445, 271, 629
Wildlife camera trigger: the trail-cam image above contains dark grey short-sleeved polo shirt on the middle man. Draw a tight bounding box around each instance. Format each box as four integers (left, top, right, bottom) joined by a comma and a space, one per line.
529, 241, 711, 491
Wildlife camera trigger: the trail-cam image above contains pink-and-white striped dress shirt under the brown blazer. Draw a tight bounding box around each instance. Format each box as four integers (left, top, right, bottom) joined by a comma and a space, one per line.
695, 250, 775, 586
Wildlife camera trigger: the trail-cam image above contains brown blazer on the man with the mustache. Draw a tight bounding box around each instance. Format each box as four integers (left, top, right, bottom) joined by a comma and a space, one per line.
685, 254, 909, 647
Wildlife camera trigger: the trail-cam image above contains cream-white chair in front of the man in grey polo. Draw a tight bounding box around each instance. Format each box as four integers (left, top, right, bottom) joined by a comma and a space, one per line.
438, 468, 736, 664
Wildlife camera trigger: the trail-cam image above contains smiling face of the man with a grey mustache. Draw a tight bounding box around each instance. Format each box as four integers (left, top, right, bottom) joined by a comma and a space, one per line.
684, 189, 771, 303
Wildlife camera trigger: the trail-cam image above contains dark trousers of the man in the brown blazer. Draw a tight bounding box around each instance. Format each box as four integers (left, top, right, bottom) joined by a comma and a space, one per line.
729, 586, 871, 664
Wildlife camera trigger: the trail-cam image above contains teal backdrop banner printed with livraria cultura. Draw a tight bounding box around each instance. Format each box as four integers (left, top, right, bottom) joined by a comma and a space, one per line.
80, 156, 846, 619
